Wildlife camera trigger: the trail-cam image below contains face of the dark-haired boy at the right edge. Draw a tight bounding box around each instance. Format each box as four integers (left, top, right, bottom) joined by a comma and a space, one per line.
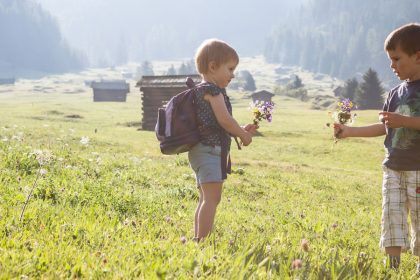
387, 46, 420, 81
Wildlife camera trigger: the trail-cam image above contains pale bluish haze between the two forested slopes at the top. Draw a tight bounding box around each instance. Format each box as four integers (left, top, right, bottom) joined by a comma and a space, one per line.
34, 0, 304, 63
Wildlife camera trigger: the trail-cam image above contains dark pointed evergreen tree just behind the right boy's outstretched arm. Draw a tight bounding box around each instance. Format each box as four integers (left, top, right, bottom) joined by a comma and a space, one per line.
355, 68, 384, 109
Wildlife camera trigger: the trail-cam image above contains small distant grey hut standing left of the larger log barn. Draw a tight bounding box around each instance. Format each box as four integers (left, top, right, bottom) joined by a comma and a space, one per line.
90, 80, 130, 102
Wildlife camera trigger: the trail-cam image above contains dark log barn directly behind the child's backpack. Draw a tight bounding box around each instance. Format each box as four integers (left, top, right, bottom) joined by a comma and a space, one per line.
136, 74, 201, 130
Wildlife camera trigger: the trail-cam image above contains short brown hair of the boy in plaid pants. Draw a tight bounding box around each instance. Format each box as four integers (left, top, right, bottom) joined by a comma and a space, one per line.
384, 23, 420, 55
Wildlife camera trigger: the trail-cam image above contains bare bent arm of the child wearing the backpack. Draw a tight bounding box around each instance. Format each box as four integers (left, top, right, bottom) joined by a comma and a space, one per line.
204, 94, 252, 146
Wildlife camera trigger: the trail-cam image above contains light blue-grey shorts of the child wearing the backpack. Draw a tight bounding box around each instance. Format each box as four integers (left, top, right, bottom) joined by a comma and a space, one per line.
188, 143, 223, 185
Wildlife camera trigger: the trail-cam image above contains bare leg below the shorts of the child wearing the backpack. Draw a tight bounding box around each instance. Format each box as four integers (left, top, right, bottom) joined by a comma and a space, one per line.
197, 182, 223, 239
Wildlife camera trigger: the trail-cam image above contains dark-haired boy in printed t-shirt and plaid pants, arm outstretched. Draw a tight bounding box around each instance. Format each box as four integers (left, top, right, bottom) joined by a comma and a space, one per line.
334, 23, 420, 273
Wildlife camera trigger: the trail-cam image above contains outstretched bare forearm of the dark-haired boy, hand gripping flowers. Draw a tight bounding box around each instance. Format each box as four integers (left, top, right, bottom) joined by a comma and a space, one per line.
334, 123, 386, 139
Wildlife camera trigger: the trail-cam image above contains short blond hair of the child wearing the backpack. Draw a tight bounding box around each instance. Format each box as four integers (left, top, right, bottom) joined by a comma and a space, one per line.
195, 39, 239, 74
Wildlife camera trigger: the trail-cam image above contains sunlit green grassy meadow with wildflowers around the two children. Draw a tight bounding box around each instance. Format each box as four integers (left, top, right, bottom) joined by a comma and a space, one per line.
0, 60, 416, 279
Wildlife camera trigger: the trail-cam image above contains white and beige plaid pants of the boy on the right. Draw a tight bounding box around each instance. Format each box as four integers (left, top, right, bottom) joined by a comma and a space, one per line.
379, 166, 420, 256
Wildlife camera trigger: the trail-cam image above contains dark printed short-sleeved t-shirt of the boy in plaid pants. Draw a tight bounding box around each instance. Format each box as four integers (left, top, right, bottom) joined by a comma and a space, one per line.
383, 80, 420, 171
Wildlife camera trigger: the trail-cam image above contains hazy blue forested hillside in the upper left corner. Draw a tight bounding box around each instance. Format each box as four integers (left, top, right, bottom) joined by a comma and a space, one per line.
0, 0, 86, 76
